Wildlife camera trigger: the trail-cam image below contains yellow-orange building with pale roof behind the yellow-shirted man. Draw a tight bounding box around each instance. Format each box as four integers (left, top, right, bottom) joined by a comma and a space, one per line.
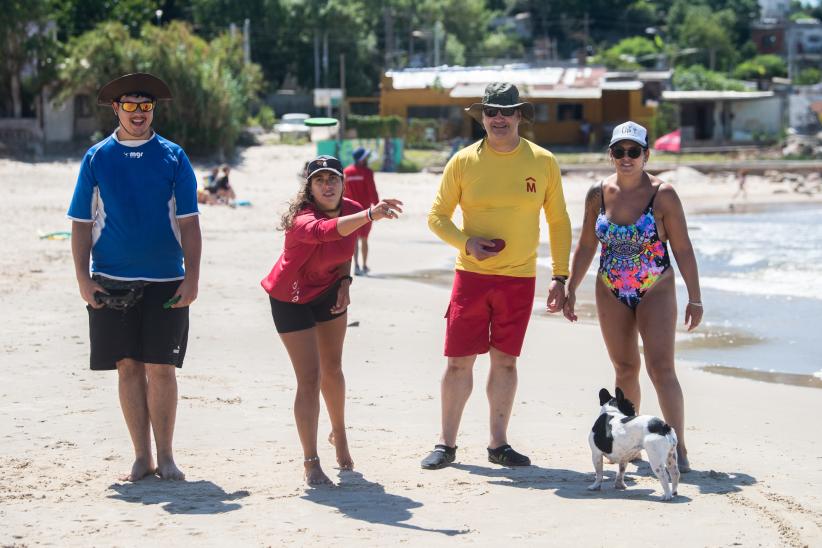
380, 66, 655, 146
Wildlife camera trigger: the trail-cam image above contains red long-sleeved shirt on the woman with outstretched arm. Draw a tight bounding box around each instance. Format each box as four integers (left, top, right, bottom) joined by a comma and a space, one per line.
261, 198, 364, 304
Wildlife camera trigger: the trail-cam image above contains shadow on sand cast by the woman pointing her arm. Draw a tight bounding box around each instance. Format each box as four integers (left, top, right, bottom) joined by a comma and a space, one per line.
301, 472, 468, 536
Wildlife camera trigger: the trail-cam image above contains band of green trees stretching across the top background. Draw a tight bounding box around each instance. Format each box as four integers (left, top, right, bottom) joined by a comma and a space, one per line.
0, 0, 822, 149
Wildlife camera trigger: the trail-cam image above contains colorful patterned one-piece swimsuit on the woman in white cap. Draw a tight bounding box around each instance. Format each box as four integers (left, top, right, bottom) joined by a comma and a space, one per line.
596, 184, 671, 310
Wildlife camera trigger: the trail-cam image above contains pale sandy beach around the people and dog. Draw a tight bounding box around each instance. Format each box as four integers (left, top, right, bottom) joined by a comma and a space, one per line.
0, 146, 822, 547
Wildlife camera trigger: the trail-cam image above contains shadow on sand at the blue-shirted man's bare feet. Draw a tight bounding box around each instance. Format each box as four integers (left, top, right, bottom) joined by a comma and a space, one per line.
108, 478, 249, 514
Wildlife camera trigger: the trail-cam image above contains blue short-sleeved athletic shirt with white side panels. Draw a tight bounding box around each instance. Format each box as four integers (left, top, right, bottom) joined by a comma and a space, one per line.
68, 133, 200, 281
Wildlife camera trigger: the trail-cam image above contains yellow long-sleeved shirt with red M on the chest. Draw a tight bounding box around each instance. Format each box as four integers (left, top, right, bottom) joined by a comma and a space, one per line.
428, 138, 571, 277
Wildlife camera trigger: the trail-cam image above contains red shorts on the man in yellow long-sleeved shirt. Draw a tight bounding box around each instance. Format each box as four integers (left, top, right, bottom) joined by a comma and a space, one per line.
445, 270, 536, 358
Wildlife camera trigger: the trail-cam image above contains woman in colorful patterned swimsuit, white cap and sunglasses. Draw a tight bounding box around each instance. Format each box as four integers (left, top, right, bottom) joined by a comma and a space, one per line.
563, 122, 702, 471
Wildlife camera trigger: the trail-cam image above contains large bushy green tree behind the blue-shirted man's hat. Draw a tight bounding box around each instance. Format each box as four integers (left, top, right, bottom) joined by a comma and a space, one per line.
60, 22, 262, 154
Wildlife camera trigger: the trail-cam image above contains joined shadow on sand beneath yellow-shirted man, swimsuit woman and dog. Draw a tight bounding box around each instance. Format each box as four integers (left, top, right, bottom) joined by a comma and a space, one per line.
452, 461, 756, 503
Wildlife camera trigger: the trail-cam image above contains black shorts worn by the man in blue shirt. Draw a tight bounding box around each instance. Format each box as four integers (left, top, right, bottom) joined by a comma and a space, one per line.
86, 280, 188, 371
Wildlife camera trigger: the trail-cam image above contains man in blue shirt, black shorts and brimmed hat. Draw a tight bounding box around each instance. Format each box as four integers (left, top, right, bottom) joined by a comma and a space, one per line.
68, 73, 202, 481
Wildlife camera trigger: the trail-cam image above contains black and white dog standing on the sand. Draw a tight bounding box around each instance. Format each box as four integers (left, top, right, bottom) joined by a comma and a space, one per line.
588, 388, 679, 500
